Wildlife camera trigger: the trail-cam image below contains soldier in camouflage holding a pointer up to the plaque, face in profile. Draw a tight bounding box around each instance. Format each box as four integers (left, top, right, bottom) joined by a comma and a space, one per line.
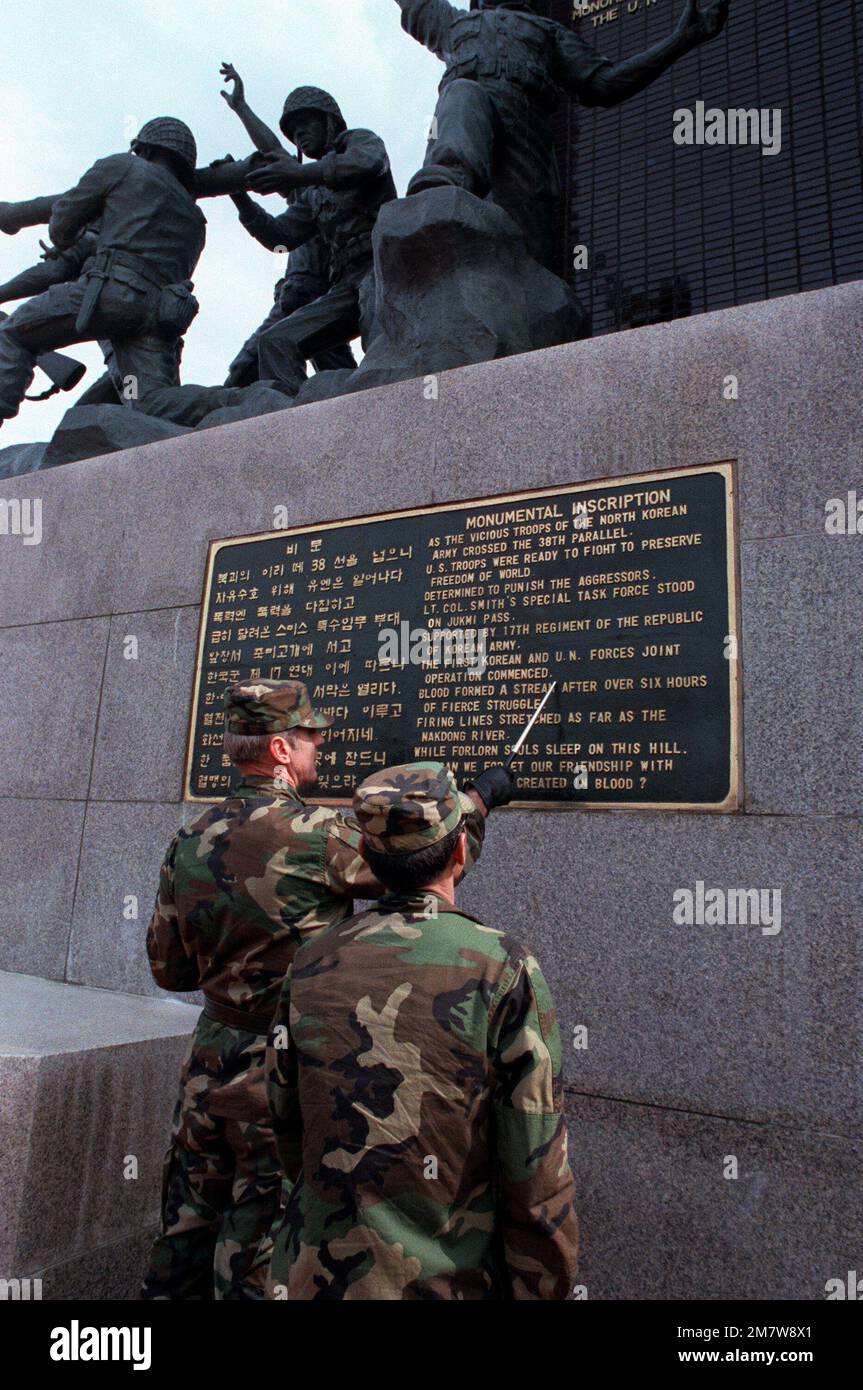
145, 681, 484, 1298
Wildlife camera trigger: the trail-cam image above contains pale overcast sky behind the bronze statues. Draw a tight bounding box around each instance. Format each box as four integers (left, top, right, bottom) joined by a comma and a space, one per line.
0, 0, 442, 448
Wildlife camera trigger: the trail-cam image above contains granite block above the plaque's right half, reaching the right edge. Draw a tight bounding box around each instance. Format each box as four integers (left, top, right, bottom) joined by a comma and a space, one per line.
433, 284, 863, 537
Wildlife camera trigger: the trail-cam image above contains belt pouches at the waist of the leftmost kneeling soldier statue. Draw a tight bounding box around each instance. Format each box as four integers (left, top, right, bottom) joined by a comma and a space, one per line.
75, 250, 199, 338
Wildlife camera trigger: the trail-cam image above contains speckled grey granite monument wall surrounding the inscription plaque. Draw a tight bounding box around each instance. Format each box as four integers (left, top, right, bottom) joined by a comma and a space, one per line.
0, 284, 863, 1300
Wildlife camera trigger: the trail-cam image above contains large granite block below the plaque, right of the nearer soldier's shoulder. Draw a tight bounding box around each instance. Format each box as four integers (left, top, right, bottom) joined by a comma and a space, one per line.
460, 812, 863, 1136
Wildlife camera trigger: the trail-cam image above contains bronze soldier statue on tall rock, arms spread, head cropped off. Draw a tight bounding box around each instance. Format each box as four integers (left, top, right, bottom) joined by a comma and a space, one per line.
396, 0, 730, 267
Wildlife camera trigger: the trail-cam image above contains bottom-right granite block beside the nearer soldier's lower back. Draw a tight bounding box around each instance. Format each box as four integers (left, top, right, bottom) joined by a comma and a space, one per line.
567, 1097, 863, 1301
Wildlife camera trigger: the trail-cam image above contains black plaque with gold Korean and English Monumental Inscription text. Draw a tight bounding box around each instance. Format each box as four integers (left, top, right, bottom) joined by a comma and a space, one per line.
185, 463, 741, 812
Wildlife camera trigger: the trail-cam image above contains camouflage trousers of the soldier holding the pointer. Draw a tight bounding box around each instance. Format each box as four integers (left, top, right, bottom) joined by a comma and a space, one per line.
142, 1016, 282, 1300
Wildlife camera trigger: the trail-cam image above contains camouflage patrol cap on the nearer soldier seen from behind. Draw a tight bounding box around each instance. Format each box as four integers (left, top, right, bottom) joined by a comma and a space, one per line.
353, 763, 474, 855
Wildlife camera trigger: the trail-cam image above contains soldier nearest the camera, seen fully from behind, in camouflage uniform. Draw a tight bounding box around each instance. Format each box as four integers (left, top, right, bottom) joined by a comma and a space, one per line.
267, 763, 578, 1300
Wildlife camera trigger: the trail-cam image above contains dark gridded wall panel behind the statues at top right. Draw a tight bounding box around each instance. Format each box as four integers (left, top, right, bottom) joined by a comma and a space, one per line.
547, 0, 863, 334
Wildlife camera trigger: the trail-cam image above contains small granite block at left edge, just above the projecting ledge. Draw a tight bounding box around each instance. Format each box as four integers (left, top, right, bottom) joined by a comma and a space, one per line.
0, 798, 85, 980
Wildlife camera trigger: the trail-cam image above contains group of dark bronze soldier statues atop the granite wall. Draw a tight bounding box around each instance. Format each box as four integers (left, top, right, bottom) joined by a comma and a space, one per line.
0, 0, 730, 439
